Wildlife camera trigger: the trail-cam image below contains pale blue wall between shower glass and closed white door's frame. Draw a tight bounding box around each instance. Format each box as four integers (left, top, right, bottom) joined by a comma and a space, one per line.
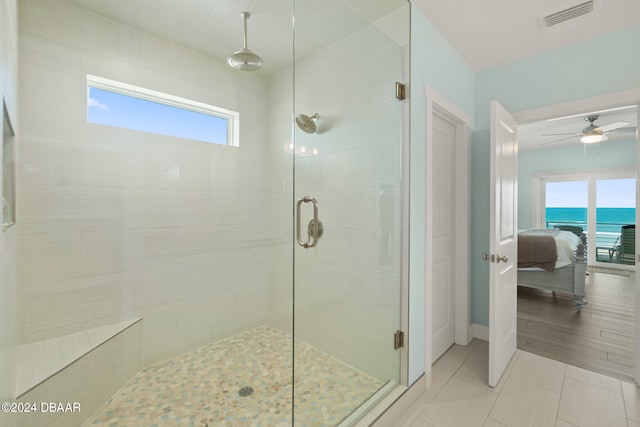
409, 1, 475, 384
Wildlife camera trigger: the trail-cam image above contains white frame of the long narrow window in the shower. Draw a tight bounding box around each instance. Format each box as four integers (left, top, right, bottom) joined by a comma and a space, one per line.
86, 74, 240, 147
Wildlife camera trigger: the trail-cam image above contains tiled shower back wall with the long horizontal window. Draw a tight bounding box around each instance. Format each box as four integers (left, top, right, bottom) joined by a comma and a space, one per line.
18, 0, 272, 363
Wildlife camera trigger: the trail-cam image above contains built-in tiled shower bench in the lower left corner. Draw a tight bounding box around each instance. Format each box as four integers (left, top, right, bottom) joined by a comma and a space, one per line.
15, 318, 143, 427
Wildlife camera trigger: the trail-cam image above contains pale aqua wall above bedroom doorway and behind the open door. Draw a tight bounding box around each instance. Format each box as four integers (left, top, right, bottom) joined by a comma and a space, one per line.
471, 26, 640, 325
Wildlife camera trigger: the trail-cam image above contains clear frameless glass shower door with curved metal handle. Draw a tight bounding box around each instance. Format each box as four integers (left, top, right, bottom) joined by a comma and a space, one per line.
291, 0, 409, 425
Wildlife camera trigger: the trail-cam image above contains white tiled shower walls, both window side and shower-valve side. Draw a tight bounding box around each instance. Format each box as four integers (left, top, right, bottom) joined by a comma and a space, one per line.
18, 0, 408, 379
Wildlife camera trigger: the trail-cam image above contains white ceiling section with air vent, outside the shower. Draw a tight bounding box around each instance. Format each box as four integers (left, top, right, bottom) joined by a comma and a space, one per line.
413, 0, 640, 71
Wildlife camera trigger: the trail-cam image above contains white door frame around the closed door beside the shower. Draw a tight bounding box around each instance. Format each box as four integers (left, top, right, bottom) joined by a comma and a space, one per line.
424, 84, 473, 378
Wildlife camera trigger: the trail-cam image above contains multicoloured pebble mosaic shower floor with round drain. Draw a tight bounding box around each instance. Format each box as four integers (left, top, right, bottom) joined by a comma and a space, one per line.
83, 325, 383, 427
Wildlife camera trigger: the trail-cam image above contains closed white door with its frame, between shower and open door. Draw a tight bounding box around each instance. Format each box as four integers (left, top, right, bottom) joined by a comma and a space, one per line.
425, 85, 472, 373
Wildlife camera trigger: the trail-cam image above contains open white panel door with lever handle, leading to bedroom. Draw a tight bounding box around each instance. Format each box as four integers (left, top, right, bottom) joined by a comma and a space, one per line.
488, 101, 518, 387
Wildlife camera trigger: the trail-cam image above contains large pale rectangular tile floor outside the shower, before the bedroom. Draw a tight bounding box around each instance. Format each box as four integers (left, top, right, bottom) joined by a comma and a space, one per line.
394, 340, 640, 427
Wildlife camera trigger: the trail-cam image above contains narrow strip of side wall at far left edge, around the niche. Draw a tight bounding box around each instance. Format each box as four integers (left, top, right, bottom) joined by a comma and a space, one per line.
0, 0, 18, 418
